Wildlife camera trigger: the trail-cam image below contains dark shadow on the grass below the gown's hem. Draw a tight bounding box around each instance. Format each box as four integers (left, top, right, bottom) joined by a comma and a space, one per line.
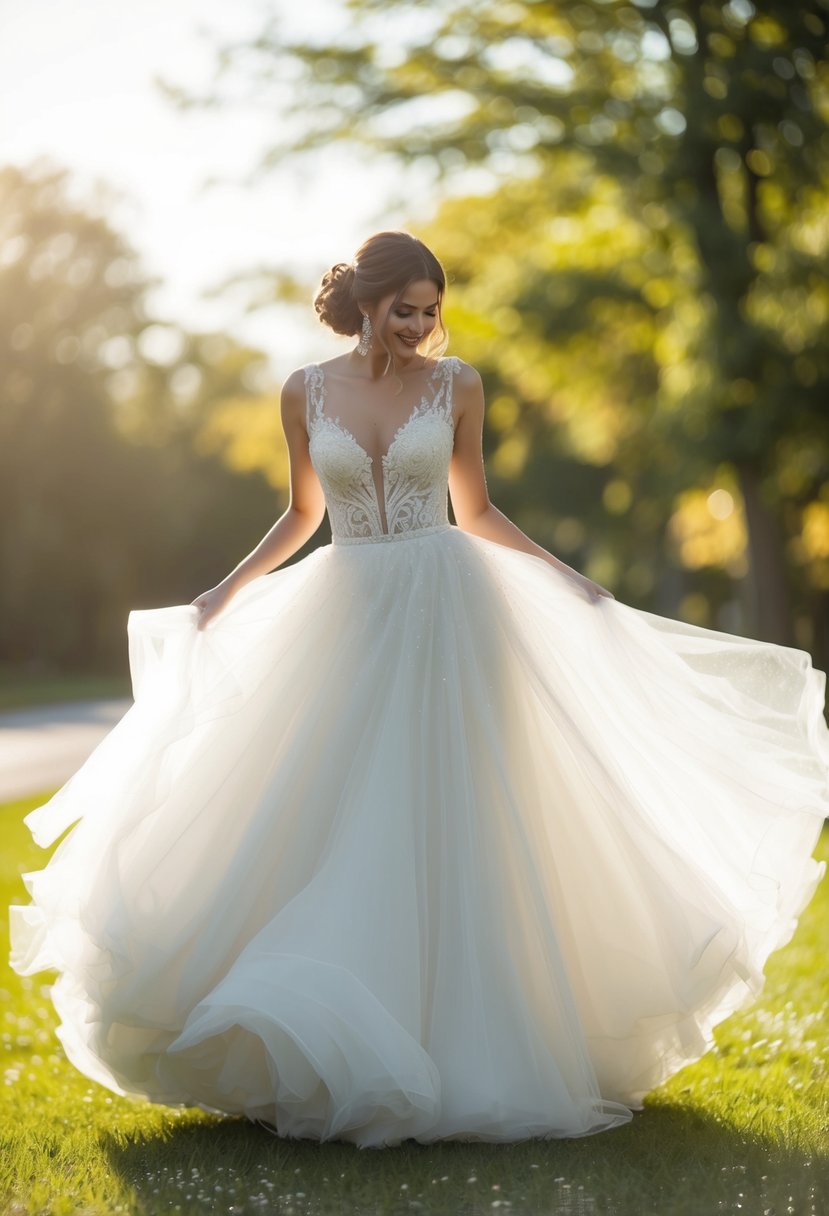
101, 1103, 829, 1216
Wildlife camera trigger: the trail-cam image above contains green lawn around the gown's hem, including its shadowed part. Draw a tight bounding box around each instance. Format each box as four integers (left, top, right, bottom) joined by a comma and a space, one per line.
0, 798, 829, 1216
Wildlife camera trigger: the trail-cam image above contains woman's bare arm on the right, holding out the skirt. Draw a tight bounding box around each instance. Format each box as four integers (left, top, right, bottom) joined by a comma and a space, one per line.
449, 364, 613, 598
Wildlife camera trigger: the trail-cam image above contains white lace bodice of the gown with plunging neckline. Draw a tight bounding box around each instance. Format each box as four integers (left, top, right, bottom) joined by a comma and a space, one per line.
305, 356, 461, 544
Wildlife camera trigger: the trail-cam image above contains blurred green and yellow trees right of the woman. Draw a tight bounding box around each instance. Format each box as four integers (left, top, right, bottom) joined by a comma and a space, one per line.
168, 0, 829, 668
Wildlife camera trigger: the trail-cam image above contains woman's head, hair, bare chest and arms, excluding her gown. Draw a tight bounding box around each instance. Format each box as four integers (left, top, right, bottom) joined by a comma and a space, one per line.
193, 232, 613, 629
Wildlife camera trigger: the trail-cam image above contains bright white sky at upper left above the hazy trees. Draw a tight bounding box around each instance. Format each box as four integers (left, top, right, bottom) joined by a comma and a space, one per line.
0, 0, 425, 377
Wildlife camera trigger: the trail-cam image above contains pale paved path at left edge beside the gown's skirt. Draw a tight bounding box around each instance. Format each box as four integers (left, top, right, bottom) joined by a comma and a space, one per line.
0, 699, 132, 803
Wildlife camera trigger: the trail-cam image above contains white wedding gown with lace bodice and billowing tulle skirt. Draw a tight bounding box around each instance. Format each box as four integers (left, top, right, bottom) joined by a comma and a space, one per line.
11, 358, 829, 1147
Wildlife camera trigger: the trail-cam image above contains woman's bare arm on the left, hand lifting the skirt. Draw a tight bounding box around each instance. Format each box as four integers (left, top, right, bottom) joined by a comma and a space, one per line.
192, 368, 326, 629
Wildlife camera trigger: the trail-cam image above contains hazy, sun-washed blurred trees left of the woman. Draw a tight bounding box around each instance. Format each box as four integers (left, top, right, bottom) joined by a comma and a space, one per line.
0, 168, 296, 671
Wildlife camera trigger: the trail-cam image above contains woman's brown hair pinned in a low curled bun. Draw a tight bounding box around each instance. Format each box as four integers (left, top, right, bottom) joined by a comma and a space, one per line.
314, 232, 449, 362
